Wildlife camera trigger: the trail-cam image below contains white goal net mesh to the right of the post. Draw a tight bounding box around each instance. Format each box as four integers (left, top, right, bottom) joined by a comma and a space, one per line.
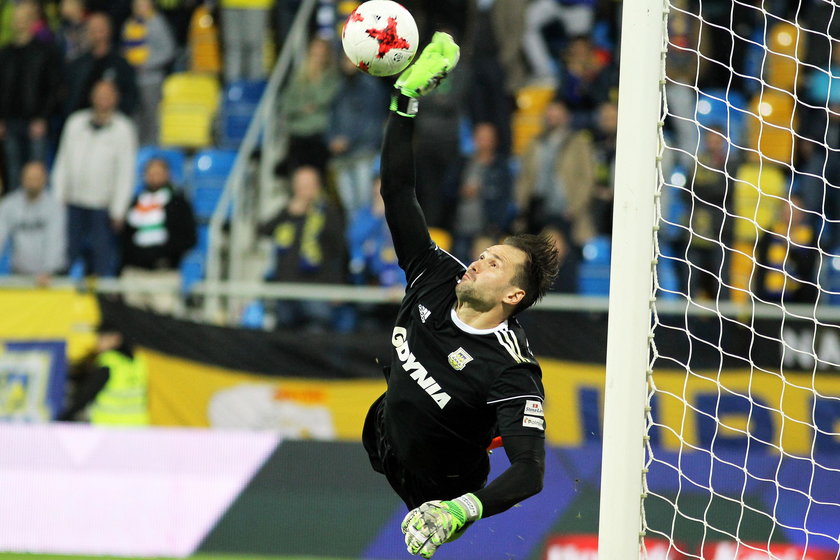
643, 0, 840, 560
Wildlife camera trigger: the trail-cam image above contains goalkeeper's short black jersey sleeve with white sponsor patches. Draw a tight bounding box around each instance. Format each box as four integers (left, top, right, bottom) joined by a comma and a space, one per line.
487, 367, 546, 441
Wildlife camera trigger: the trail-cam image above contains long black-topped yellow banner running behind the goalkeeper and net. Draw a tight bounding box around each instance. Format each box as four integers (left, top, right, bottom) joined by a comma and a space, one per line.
101, 300, 840, 455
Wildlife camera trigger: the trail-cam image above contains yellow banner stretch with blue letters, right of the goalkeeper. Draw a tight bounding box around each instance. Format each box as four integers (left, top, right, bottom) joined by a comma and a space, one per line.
540, 358, 840, 455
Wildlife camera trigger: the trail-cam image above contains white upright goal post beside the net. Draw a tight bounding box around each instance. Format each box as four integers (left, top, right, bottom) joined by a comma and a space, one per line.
598, 0, 664, 560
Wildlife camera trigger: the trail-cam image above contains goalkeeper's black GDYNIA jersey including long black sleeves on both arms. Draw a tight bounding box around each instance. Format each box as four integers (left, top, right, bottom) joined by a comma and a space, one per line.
381, 110, 545, 490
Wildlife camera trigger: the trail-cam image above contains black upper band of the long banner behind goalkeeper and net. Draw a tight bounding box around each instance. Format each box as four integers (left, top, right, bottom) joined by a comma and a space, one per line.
99, 298, 840, 379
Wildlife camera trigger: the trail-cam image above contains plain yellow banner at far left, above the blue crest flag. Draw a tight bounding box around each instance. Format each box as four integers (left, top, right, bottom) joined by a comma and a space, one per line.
0, 288, 99, 361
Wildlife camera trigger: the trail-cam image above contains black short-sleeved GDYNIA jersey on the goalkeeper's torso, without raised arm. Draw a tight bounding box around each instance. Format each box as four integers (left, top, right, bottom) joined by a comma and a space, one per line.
385, 244, 545, 476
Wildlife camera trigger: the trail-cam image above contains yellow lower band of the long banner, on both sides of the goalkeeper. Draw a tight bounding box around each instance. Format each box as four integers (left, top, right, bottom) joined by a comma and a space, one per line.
144, 351, 840, 454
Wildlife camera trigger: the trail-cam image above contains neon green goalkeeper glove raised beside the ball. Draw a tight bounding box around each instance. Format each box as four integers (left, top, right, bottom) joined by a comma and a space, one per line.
391, 31, 461, 117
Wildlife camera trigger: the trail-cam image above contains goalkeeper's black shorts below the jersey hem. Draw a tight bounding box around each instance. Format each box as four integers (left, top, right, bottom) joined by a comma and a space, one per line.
362, 394, 489, 509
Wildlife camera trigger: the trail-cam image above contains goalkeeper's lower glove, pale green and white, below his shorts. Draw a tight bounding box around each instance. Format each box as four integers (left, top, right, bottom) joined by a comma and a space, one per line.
402, 494, 483, 558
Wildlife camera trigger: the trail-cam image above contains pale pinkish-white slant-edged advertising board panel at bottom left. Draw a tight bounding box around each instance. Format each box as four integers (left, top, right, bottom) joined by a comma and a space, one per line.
0, 423, 279, 558
